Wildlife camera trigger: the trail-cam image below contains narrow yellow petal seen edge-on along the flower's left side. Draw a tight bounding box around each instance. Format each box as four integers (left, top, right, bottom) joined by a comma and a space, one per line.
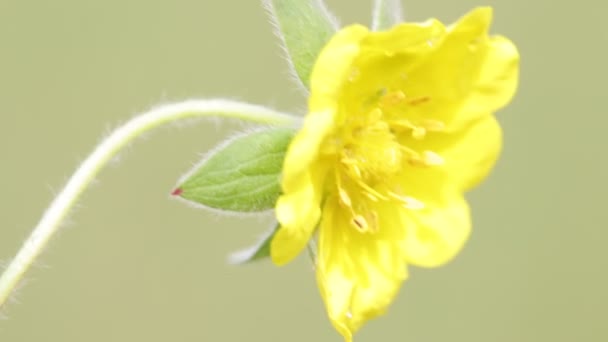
271, 25, 368, 265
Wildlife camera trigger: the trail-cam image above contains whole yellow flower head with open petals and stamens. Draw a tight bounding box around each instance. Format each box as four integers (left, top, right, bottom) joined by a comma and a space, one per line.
271, 8, 519, 341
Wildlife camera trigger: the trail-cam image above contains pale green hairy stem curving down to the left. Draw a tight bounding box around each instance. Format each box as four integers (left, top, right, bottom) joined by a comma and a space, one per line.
0, 100, 299, 308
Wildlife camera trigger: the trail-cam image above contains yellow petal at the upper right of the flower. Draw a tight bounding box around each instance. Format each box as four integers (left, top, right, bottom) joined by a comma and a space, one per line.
390, 8, 519, 131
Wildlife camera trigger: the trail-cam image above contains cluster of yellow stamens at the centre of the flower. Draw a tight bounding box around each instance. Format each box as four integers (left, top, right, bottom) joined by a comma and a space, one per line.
335, 89, 444, 233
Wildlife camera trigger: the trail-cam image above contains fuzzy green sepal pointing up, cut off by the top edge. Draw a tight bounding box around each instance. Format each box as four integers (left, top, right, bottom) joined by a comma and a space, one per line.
264, 0, 339, 88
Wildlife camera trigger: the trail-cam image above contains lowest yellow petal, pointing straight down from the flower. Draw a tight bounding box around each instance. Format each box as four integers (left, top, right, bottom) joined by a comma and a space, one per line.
317, 198, 407, 341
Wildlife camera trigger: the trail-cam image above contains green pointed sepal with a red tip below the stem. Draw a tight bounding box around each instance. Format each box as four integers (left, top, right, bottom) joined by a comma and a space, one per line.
173, 128, 295, 212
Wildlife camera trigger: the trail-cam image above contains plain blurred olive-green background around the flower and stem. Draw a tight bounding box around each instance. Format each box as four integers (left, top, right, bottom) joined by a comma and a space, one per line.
0, 0, 608, 342
